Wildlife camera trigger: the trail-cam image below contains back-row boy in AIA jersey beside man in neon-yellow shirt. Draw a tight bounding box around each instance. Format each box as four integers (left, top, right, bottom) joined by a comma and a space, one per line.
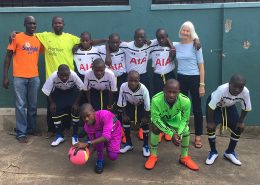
73, 32, 100, 81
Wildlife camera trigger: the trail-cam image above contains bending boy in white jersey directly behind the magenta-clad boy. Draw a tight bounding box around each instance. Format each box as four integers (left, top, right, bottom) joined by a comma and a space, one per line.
84, 58, 117, 111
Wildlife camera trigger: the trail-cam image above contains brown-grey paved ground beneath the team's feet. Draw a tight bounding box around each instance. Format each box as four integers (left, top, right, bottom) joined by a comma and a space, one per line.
0, 129, 260, 185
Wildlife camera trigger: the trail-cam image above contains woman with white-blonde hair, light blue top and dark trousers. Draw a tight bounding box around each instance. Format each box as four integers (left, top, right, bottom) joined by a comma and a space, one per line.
174, 21, 205, 148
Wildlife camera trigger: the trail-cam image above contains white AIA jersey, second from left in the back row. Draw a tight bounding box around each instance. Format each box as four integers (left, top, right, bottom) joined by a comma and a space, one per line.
98, 45, 126, 77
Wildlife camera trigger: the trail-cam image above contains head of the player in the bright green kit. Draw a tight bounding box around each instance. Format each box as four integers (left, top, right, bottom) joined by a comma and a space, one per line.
163, 81, 180, 104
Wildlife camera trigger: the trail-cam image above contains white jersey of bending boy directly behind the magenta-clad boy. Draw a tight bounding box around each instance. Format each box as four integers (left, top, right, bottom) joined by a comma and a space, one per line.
83, 68, 117, 91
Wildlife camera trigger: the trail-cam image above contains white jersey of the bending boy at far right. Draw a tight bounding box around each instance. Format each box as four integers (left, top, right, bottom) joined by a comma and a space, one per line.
209, 83, 252, 111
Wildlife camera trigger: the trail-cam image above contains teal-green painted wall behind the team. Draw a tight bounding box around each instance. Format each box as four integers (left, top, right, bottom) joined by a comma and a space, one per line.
0, 0, 260, 124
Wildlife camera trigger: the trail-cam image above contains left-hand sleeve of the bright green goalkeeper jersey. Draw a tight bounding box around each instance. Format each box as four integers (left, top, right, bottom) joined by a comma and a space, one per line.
151, 99, 174, 137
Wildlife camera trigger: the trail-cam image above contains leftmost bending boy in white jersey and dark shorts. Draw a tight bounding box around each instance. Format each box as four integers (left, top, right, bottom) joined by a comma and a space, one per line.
42, 64, 83, 146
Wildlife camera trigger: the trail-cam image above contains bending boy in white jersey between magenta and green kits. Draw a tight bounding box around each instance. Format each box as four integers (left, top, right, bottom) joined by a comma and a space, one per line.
117, 70, 150, 157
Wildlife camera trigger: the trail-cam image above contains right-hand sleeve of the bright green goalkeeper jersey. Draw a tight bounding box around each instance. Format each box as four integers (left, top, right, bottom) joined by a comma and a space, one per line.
178, 98, 191, 135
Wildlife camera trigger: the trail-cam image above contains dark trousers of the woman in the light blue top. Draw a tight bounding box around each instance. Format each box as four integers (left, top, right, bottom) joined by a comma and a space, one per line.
177, 74, 203, 136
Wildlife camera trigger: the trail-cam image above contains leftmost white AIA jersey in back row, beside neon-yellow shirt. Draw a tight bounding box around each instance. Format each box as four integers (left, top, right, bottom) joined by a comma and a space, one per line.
73, 46, 100, 75
